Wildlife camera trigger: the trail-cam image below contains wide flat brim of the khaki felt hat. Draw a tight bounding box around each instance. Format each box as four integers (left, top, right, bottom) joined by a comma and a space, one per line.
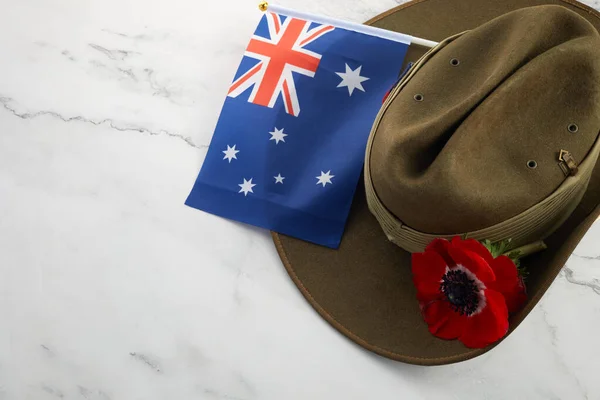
272, 0, 600, 365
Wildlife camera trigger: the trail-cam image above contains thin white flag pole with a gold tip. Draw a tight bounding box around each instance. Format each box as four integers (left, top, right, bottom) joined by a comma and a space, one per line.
258, 1, 437, 48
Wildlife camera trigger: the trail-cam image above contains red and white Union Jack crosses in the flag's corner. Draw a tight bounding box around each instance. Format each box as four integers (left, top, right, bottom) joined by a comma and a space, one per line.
228, 13, 335, 117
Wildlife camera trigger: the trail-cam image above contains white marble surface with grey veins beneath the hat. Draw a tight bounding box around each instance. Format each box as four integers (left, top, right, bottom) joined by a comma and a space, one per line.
0, 0, 600, 400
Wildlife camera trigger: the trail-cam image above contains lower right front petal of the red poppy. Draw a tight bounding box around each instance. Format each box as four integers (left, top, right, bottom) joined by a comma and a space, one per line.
459, 290, 508, 348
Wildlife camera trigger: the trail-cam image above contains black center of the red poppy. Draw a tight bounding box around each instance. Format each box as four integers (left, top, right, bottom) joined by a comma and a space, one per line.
440, 270, 479, 315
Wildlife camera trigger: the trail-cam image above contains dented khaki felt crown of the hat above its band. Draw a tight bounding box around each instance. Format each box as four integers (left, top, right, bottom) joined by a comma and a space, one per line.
367, 6, 600, 245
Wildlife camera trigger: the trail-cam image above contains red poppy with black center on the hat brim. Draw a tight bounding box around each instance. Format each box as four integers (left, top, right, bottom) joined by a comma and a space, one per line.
412, 237, 526, 348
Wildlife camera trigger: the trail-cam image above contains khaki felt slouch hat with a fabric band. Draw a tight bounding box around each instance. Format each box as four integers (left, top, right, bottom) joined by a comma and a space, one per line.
273, 0, 600, 365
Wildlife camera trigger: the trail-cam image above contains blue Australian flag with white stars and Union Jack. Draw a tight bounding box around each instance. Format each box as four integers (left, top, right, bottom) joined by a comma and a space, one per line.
186, 12, 408, 248
